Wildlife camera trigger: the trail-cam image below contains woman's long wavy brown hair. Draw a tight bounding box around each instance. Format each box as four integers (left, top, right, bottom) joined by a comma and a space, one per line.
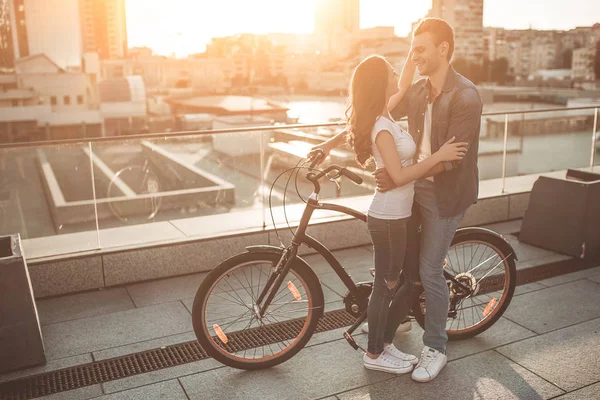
346, 55, 389, 167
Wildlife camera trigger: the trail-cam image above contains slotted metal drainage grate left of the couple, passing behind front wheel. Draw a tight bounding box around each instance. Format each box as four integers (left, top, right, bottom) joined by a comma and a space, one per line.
0, 309, 356, 400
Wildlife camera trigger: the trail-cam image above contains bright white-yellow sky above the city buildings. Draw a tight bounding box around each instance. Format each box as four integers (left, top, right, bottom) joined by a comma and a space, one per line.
126, 0, 600, 56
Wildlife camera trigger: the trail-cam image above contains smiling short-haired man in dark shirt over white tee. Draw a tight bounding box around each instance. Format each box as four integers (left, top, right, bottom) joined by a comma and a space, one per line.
314, 18, 482, 382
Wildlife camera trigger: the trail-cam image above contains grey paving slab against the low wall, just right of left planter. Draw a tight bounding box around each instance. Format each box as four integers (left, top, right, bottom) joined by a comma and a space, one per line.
37, 288, 135, 325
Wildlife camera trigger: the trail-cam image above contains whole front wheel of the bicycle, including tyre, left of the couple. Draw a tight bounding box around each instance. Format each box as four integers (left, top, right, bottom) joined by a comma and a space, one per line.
192, 251, 323, 369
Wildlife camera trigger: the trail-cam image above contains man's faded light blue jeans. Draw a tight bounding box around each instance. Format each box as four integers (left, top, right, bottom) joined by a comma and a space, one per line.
408, 180, 464, 352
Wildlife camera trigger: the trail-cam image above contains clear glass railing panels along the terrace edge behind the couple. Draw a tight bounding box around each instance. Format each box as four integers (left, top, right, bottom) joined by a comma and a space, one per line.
0, 107, 600, 257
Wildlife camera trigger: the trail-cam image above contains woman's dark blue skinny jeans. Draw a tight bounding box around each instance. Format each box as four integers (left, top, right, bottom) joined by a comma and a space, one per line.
367, 216, 408, 354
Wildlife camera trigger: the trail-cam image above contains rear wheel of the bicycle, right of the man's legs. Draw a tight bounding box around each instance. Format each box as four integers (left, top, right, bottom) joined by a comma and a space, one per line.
413, 232, 517, 340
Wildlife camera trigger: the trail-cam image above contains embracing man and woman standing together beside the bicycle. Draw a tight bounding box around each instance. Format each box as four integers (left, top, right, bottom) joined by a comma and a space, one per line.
313, 18, 482, 382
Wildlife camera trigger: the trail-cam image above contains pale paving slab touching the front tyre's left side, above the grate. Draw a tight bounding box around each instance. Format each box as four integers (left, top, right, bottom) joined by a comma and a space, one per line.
42, 302, 192, 360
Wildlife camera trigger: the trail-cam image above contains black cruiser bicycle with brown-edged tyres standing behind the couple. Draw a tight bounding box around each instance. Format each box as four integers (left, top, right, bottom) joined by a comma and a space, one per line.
192, 154, 517, 370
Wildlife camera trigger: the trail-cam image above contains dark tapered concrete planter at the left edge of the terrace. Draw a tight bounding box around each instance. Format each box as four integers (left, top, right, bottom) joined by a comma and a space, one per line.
0, 234, 46, 373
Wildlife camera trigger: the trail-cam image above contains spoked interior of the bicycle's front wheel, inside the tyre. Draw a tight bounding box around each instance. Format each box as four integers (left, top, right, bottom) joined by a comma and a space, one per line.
203, 260, 314, 362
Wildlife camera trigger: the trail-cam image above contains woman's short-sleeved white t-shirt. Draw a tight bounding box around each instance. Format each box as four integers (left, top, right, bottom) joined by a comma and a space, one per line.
369, 116, 417, 219
